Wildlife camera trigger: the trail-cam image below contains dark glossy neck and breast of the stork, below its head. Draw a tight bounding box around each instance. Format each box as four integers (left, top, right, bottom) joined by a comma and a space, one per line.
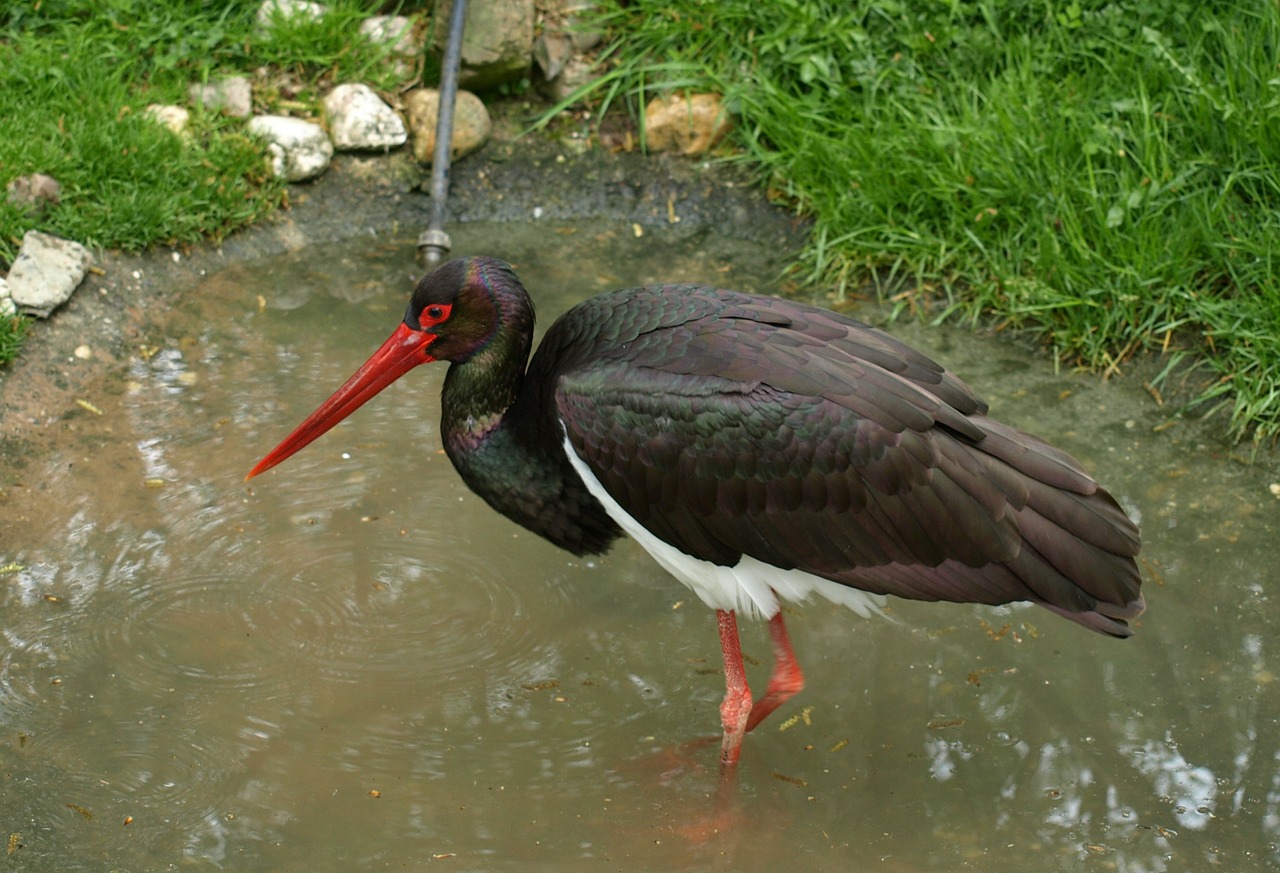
440, 322, 621, 554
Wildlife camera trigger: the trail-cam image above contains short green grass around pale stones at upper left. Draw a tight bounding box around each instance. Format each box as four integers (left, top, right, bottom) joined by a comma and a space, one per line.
0, 0, 419, 364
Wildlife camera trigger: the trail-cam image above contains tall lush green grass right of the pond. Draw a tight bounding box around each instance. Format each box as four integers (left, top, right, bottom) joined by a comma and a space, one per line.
565, 0, 1280, 442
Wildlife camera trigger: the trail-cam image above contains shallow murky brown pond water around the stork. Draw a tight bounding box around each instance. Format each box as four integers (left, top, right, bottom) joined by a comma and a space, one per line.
0, 224, 1280, 873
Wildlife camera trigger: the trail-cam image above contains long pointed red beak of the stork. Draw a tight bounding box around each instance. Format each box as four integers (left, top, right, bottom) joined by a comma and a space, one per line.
244, 323, 435, 480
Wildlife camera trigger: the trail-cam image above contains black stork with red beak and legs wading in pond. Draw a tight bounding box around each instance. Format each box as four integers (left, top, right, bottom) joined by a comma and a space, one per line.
248, 257, 1144, 769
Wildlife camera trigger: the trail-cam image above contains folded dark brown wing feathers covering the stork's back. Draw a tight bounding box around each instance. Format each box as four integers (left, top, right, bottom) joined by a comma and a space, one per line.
531, 287, 1143, 636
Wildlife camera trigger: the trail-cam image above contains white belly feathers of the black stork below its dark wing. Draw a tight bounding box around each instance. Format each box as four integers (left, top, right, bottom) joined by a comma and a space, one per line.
564, 434, 884, 618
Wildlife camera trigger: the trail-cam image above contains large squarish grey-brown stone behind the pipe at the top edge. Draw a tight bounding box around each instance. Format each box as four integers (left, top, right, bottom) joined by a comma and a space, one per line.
431, 0, 535, 91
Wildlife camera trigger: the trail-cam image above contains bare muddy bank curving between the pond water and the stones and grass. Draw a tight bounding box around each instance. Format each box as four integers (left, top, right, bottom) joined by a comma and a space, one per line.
0, 136, 803, 455
